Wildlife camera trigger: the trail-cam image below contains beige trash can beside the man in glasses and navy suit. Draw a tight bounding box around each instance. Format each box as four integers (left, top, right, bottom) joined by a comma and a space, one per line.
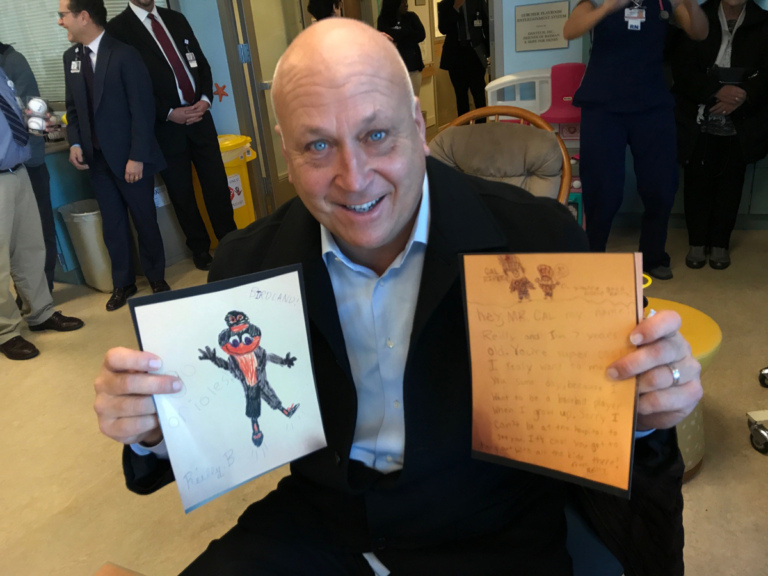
59, 200, 112, 292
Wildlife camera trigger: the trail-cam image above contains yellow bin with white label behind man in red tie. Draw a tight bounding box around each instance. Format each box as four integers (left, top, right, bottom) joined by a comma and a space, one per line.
192, 134, 256, 248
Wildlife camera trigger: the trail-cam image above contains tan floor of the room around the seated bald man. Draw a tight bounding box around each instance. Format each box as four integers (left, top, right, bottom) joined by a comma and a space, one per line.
0, 230, 768, 576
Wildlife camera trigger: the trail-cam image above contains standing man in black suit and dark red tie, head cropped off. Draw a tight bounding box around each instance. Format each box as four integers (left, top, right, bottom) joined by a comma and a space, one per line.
107, 0, 236, 270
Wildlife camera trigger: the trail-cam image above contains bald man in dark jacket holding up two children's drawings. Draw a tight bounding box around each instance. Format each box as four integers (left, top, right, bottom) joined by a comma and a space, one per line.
95, 19, 701, 576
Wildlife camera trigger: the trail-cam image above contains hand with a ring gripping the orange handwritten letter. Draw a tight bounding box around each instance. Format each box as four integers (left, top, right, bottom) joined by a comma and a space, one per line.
607, 310, 703, 430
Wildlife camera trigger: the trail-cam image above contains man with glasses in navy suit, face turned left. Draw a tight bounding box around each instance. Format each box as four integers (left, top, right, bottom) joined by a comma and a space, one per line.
59, 0, 170, 311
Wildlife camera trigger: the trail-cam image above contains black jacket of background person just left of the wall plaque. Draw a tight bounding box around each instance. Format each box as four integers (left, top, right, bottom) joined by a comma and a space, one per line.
437, 0, 491, 70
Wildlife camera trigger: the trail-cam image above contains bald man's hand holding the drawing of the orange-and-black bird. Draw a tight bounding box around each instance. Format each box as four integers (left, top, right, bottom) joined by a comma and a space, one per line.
93, 348, 181, 446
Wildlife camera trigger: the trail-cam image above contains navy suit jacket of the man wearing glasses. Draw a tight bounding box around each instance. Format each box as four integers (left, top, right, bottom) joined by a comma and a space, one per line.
64, 33, 165, 178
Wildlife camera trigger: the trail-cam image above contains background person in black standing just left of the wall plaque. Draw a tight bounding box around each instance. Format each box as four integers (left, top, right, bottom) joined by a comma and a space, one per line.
437, 0, 491, 116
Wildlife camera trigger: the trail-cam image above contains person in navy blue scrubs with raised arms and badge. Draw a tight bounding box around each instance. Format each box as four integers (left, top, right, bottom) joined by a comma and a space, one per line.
563, 0, 709, 280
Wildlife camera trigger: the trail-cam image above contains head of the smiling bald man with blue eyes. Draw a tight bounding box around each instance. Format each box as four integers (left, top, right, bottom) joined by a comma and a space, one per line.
275, 21, 429, 274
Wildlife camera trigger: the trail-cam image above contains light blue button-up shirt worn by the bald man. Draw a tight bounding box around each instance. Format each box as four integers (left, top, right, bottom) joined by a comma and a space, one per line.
320, 176, 429, 473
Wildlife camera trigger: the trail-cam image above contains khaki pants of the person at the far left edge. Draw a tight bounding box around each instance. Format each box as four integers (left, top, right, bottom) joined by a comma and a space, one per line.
0, 167, 54, 344
